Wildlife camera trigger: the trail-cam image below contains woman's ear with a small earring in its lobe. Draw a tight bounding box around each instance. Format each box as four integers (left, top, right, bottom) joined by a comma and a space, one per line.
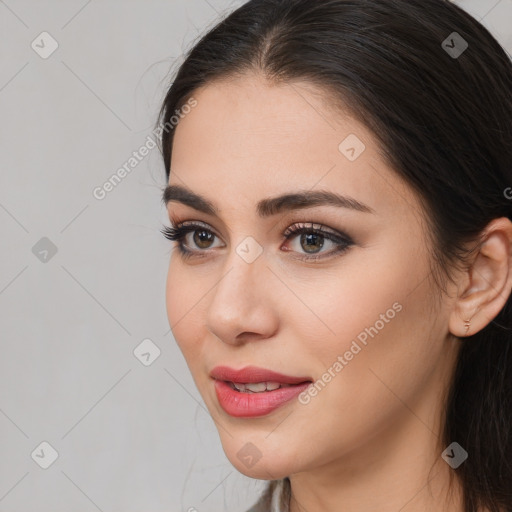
449, 217, 512, 337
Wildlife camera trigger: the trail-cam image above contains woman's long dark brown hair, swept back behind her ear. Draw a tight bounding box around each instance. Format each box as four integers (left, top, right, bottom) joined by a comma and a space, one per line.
157, 0, 512, 512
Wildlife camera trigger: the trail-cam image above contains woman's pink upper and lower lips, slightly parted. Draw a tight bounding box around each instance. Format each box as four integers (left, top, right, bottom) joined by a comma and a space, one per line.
210, 366, 312, 418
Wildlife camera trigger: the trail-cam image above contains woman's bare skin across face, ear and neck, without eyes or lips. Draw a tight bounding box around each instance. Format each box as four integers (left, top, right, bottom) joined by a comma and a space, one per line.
166, 74, 512, 512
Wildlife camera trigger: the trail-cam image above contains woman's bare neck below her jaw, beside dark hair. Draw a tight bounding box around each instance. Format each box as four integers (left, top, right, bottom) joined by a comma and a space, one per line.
290, 412, 464, 512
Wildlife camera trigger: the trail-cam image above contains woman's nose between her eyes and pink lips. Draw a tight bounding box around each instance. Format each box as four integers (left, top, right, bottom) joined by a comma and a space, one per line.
206, 249, 278, 345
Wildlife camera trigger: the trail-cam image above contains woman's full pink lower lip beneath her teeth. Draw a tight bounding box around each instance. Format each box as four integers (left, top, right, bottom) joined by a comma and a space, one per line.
215, 379, 311, 418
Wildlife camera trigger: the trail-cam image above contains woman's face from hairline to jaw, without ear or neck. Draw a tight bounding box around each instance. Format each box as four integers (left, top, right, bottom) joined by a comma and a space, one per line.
167, 75, 456, 479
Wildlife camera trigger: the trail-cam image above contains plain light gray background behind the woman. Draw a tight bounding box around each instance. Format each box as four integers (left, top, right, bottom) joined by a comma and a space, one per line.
0, 0, 512, 512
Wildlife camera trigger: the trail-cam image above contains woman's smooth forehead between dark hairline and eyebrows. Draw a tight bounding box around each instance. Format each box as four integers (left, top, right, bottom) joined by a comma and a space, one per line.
169, 74, 419, 222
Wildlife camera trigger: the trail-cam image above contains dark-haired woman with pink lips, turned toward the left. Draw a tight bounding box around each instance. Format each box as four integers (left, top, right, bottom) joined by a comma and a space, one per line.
155, 0, 512, 512
